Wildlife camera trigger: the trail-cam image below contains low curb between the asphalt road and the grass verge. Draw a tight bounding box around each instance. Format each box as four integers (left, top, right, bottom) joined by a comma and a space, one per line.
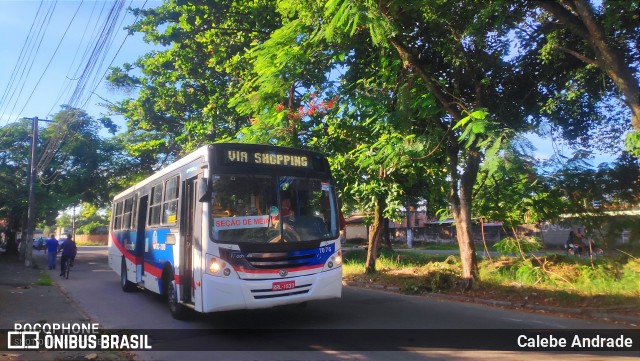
342, 281, 640, 327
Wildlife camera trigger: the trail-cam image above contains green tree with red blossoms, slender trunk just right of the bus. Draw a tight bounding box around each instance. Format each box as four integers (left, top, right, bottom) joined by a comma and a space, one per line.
234, 1, 450, 272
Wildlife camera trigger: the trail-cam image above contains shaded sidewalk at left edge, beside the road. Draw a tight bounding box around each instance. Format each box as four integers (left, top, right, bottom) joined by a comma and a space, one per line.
0, 250, 133, 361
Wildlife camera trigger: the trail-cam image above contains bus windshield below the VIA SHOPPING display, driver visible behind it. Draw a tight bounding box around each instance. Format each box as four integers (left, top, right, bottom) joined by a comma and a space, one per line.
210, 175, 338, 244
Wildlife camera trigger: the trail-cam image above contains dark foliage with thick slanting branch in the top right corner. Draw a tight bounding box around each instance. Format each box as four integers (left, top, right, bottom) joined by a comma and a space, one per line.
520, 0, 640, 155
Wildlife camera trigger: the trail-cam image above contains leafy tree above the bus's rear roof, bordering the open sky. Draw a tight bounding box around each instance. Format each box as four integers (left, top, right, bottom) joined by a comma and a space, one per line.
108, 0, 280, 160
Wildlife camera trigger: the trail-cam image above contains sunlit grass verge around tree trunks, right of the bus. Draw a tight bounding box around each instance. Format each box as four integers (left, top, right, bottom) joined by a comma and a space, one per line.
343, 250, 640, 316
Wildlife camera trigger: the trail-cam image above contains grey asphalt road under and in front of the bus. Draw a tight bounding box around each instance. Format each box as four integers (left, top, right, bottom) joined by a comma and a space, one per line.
48, 247, 626, 360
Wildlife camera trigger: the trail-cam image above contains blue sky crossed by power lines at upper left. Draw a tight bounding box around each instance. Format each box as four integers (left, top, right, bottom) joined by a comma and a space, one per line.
0, 0, 161, 130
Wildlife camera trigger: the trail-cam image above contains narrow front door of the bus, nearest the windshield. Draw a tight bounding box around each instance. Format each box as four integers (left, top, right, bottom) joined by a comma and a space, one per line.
180, 177, 198, 303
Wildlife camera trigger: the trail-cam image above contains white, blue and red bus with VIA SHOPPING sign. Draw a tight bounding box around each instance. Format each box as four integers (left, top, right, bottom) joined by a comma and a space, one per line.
109, 144, 342, 318
